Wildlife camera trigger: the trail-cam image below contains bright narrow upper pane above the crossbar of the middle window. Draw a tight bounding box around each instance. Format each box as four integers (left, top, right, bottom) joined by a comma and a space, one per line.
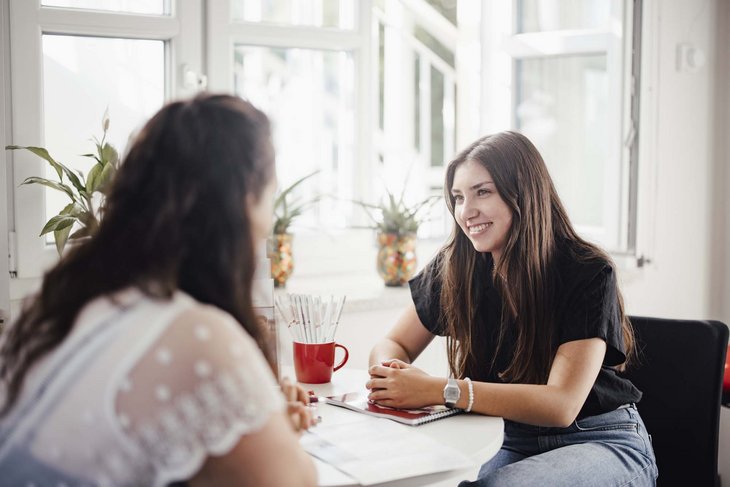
232, 0, 357, 29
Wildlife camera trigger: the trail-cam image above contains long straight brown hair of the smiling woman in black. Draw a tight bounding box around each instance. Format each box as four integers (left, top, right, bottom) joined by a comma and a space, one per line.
440, 132, 634, 384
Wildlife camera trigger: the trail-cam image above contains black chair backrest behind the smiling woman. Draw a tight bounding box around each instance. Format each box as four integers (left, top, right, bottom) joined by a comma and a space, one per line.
623, 316, 728, 487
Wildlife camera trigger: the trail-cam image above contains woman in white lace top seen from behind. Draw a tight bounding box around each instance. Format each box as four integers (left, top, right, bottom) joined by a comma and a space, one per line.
0, 95, 316, 486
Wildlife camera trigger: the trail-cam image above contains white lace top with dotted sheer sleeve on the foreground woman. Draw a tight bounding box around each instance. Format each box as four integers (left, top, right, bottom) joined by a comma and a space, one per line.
0, 290, 284, 486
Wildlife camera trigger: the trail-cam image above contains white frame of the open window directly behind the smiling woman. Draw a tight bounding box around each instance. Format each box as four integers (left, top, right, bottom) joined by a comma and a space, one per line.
481, 0, 638, 255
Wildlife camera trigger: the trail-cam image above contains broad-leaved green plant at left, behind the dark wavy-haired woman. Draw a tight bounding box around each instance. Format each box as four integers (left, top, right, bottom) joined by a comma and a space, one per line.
5, 112, 119, 255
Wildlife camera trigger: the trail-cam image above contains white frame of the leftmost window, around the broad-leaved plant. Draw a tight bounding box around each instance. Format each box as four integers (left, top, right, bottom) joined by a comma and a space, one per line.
6, 0, 203, 294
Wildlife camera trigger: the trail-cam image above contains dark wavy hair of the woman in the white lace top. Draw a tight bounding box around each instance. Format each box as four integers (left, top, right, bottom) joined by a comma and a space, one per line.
0, 94, 275, 413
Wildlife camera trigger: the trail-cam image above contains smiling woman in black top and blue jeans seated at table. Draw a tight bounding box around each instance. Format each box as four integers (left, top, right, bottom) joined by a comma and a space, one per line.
367, 132, 657, 486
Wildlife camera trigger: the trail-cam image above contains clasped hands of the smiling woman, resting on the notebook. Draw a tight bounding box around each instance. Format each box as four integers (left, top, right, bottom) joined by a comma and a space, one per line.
365, 359, 445, 409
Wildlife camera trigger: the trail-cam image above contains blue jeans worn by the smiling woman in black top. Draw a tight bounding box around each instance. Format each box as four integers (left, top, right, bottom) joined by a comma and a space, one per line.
459, 405, 657, 487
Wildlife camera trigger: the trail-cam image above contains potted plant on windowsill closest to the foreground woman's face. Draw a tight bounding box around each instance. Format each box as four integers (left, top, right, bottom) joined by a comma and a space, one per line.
268, 171, 321, 287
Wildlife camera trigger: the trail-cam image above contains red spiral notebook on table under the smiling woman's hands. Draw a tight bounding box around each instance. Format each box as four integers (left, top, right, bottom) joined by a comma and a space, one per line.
326, 392, 463, 426
